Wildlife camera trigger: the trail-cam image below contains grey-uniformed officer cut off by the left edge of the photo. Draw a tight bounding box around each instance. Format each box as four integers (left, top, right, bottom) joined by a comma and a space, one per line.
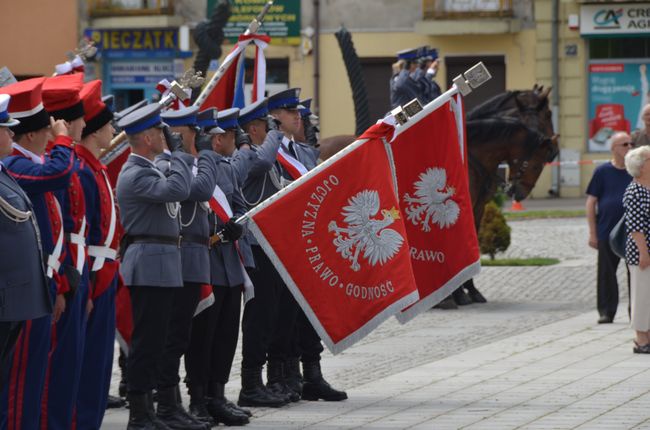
0, 94, 52, 388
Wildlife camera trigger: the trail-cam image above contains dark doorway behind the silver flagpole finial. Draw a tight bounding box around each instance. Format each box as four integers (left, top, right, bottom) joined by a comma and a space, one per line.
445, 55, 506, 111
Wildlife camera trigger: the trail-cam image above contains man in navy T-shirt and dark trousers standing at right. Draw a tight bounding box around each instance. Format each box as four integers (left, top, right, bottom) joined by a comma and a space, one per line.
586, 132, 633, 324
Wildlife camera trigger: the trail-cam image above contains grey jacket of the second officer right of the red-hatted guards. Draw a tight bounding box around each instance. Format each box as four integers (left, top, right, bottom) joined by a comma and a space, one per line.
155, 151, 221, 284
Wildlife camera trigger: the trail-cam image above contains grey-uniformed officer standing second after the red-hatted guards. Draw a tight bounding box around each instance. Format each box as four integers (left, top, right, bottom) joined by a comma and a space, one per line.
155, 106, 221, 429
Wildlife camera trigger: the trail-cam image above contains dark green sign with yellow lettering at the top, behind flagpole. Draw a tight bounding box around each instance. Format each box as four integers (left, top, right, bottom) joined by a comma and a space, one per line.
207, 0, 301, 45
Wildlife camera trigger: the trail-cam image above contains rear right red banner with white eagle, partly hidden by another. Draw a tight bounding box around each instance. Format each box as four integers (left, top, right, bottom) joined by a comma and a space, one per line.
391, 95, 481, 323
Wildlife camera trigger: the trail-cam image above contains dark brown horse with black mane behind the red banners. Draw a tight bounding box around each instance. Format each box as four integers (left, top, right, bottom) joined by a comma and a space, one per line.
319, 85, 558, 231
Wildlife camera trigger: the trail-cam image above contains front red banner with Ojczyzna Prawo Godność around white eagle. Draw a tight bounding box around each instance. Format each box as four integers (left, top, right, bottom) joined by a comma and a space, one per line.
249, 138, 418, 354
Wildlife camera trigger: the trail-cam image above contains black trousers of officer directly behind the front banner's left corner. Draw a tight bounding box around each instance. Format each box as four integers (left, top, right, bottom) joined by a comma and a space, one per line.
242, 245, 287, 369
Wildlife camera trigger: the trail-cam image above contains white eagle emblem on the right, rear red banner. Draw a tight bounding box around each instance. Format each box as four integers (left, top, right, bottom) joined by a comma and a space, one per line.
404, 167, 460, 231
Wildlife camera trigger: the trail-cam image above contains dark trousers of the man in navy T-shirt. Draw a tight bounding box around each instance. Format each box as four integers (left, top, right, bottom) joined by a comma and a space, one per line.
596, 240, 630, 318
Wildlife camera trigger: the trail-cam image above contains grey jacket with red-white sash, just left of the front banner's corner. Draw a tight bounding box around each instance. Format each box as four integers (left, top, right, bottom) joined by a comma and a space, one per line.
209, 159, 246, 287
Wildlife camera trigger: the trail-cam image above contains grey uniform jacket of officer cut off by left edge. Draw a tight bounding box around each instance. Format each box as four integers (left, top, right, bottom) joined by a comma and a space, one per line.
0, 165, 52, 321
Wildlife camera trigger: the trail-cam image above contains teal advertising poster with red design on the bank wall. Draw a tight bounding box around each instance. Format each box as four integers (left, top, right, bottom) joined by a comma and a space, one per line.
588, 61, 650, 152
